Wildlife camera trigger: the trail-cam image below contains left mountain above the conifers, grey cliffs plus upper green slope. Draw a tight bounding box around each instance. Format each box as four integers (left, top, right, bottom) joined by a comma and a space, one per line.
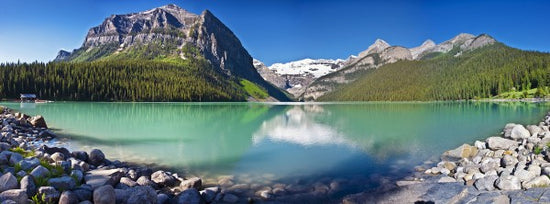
56, 4, 290, 101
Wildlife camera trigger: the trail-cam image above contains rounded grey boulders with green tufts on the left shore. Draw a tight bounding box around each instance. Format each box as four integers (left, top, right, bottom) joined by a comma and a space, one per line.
0, 106, 243, 204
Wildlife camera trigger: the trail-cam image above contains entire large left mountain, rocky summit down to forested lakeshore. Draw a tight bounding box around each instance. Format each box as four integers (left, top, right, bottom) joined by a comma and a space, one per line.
42, 4, 291, 101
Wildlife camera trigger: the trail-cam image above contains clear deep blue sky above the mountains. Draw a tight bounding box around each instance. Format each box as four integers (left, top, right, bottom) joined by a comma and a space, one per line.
0, 0, 550, 65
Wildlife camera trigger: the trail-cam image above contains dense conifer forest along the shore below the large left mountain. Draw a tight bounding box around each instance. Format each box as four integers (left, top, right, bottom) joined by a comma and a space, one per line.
0, 59, 251, 101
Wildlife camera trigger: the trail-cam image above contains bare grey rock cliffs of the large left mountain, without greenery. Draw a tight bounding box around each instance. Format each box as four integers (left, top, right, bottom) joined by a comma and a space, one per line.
54, 4, 289, 100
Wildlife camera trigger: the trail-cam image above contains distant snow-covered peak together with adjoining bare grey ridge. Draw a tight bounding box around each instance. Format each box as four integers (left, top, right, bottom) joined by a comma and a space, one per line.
255, 33, 502, 101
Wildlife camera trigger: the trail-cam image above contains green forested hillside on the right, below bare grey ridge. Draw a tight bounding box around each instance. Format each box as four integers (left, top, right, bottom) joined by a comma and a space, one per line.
319, 43, 550, 101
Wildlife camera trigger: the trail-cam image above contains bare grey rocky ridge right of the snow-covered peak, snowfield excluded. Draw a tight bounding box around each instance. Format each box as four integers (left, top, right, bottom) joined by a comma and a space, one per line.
306, 33, 496, 101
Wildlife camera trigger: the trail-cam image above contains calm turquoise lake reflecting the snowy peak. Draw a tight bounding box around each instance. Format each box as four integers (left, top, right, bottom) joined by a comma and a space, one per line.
2, 102, 550, 199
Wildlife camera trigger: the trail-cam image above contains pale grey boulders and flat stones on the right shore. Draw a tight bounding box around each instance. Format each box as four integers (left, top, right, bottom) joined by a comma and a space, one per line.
343, 112, 550, 203
